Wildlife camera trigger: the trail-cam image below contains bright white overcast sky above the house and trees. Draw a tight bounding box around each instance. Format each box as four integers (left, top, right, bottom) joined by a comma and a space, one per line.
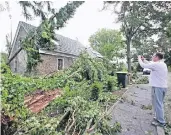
0, 0, 120, 52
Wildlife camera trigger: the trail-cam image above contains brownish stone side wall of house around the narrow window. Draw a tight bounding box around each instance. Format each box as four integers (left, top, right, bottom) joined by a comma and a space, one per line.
36, 54, 73, 75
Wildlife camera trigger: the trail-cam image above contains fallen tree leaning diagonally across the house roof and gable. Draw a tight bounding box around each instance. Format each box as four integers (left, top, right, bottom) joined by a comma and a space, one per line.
7, 1, 84, 72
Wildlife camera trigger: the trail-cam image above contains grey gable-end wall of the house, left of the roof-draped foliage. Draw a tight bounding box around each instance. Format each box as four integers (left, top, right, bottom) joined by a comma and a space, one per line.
10, 27, 27, 74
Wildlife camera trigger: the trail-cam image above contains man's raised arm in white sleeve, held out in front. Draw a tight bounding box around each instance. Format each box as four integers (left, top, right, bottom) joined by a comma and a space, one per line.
138, 56, 155, 70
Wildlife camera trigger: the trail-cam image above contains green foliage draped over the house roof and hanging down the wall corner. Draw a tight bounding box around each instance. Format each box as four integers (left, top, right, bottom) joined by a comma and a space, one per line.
22, 20, 55, 73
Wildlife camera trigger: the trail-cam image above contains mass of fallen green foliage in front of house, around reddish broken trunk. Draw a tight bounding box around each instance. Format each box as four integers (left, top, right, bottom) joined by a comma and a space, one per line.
1, 53, 123, 135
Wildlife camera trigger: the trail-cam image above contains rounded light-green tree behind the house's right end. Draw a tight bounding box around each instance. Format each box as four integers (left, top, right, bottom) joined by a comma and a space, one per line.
89, 28, 124, 60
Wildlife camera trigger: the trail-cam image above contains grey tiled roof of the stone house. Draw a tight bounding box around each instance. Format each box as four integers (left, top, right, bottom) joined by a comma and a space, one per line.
19, 21, 102, 57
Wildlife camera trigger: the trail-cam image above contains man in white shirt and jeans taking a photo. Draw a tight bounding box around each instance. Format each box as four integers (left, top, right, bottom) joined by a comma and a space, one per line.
138, 52, 168, 127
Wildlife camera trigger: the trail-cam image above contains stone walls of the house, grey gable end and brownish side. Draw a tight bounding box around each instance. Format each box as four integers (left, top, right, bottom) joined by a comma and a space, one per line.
10, 23, 73, 75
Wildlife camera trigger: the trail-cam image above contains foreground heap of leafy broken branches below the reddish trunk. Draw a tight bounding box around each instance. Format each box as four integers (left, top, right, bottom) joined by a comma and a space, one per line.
15, 96, 121, 135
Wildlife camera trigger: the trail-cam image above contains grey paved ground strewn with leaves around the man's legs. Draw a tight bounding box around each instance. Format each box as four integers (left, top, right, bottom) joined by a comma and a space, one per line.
112, 74, 171, 135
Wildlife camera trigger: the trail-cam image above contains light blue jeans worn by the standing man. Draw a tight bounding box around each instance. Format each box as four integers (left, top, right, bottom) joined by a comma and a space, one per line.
152, 87, 167, 124
